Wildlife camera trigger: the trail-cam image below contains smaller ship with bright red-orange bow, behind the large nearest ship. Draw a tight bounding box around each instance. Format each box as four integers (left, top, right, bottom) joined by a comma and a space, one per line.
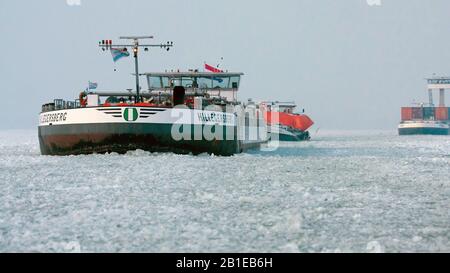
260, 101, 314, 141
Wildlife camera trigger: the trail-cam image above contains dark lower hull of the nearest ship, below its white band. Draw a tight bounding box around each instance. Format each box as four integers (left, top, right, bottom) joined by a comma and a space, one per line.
39, 123, 250, 156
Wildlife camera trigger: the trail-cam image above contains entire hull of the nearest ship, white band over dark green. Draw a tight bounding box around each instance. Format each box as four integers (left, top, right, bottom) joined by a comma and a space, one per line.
39, 106, 266, 156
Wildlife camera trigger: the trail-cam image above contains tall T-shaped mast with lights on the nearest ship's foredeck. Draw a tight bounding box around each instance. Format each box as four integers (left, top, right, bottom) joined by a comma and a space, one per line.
99, 36, 173, 103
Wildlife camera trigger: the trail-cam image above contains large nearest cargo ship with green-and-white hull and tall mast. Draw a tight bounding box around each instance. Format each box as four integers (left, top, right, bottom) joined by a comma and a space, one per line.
38, 36, 268, 156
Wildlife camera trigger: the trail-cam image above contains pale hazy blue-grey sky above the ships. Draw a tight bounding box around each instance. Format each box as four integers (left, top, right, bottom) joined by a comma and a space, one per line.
0, 0, 450, 129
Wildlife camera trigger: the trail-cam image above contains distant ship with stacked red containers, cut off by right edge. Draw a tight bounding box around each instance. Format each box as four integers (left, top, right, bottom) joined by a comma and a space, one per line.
398, 77, 450, 135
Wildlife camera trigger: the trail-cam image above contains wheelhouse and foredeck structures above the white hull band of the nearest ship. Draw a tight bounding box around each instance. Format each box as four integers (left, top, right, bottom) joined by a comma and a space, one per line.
42, 71, 244, 112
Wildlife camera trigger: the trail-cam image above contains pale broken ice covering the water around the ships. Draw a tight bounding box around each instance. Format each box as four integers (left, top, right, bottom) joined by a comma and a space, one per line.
0, 131, 450, 252
